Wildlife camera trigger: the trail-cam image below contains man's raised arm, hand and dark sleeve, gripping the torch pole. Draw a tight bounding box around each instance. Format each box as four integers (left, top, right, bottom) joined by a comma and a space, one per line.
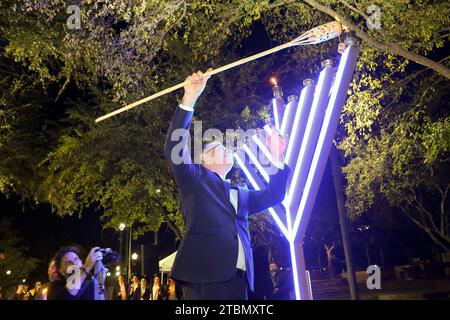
164, 71, 208, 189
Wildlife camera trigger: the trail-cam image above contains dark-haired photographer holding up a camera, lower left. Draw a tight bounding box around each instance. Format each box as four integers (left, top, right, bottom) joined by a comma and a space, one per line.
47, 246, 113, 300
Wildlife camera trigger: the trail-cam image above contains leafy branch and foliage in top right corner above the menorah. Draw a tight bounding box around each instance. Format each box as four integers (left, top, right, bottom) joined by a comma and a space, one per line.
304, 0, 450, 79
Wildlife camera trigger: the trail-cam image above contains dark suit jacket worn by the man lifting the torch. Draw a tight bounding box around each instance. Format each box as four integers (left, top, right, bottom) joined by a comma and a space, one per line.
165, 108, 289, 291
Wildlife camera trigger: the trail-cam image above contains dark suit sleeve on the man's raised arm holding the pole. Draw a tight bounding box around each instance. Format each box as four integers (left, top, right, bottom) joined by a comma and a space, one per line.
164, 107, 198, 190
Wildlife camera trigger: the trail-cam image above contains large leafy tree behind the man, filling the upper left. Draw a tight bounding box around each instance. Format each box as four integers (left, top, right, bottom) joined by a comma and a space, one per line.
0, 1, 324, 238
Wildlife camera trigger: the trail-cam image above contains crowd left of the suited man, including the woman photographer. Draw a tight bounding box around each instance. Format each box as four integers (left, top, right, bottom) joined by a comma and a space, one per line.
3, 246, 181, 300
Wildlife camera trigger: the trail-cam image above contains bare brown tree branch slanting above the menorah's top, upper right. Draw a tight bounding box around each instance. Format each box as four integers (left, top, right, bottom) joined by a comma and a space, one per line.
304, 0, 450, 79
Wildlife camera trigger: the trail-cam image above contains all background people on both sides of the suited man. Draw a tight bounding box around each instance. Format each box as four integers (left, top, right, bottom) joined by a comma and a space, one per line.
7, 246, 292, 300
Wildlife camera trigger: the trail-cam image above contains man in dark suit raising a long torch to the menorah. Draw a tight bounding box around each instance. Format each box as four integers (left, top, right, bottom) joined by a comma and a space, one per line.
165, 71, 289, 300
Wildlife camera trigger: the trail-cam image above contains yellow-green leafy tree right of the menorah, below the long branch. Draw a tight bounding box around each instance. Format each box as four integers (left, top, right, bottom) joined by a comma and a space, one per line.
340, 58, 450, 252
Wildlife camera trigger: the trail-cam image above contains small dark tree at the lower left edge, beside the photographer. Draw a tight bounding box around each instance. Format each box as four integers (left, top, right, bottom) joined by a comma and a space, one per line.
0, 217, 39, 292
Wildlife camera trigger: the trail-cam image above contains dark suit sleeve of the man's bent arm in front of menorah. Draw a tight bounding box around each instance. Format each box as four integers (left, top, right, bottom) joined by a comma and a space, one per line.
248, 165, 290, 215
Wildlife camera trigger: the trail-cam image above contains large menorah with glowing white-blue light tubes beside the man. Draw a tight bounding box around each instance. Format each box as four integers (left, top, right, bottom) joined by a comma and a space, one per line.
234, 37, 359, 300
